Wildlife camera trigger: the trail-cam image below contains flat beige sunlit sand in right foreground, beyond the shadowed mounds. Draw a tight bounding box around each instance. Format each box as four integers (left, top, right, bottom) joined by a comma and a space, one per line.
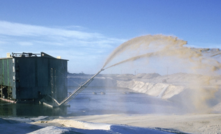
71, 114, 221, 134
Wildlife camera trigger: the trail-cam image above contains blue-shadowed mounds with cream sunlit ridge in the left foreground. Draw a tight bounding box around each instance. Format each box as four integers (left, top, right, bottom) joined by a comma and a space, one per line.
0, 117, 172, 134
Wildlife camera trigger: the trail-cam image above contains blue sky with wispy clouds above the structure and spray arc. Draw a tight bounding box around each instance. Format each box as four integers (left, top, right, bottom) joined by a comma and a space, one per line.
0, 0, 221, 74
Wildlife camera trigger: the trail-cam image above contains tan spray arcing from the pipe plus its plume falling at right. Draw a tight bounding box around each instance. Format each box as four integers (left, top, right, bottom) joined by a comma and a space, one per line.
103, 35, 221, 110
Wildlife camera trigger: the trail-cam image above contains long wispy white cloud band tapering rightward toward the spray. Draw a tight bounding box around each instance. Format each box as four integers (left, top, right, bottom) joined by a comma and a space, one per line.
0, 21, 125, 46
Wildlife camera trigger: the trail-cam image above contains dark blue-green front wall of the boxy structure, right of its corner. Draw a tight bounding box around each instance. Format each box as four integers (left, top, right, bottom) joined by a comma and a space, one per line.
16, 57, 67, 100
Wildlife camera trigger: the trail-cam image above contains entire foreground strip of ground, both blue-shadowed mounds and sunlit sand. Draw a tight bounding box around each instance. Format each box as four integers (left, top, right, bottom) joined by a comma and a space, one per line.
0, 114, 221, 134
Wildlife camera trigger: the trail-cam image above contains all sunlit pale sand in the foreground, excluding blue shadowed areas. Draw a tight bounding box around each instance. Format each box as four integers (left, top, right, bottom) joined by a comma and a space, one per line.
28, 114, 221, 134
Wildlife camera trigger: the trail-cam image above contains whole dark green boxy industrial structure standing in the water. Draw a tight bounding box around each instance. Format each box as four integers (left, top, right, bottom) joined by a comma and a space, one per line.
0, 52, 68, 102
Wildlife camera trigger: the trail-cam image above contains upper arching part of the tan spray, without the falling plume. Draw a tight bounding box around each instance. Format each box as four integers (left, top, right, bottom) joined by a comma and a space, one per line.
103, 35, 221, 72
